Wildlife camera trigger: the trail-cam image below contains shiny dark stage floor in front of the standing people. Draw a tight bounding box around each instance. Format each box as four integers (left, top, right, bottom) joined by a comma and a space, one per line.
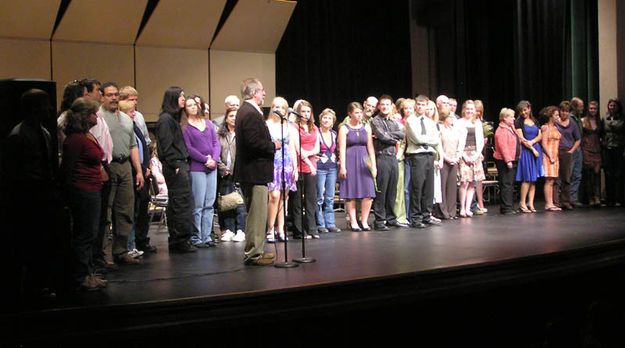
57, 207, 625, 308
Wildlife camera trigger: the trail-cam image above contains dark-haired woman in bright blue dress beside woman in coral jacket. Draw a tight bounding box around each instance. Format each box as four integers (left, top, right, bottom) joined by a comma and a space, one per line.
514, 100, 544, 213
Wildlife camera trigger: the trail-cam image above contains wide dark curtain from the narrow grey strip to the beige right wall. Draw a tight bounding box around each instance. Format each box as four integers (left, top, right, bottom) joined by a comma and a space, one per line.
432, 0, 599, 122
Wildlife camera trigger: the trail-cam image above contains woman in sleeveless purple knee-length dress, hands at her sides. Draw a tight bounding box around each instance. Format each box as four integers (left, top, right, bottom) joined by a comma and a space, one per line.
339, 102, 377, 232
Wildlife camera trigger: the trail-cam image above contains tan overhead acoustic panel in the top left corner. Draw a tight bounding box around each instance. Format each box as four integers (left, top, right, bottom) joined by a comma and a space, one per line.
0, 0, 61, 40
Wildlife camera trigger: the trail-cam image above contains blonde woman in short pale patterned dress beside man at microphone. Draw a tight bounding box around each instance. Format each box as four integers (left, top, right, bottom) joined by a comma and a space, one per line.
267, 97, 297, 243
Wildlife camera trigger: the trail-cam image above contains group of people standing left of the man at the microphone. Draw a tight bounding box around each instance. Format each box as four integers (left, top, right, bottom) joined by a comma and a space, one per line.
43, 79, 251, 290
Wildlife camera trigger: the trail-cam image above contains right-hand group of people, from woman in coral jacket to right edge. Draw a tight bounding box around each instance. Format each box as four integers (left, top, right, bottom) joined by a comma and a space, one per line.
494, 97, 625, 214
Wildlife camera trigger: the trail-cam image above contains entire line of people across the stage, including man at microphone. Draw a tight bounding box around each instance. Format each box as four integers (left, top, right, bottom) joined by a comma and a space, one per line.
10, 74, 625, 290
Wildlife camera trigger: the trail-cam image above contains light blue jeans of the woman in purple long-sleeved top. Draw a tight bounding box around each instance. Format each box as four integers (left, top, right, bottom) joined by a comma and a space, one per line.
190, 170, 217, 244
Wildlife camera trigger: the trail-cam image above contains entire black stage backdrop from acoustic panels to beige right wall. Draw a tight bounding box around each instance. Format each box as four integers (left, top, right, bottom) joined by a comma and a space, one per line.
276, 0, 599, 121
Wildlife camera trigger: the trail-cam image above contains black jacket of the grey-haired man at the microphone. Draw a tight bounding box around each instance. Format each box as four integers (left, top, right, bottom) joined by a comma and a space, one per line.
234, 102, 276, 185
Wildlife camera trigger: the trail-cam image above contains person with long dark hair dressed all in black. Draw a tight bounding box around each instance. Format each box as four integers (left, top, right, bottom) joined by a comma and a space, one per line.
155, 87, 197, 253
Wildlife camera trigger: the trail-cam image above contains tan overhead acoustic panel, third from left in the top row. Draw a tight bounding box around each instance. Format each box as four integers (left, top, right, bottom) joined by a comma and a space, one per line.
137, 0, 226, 49
